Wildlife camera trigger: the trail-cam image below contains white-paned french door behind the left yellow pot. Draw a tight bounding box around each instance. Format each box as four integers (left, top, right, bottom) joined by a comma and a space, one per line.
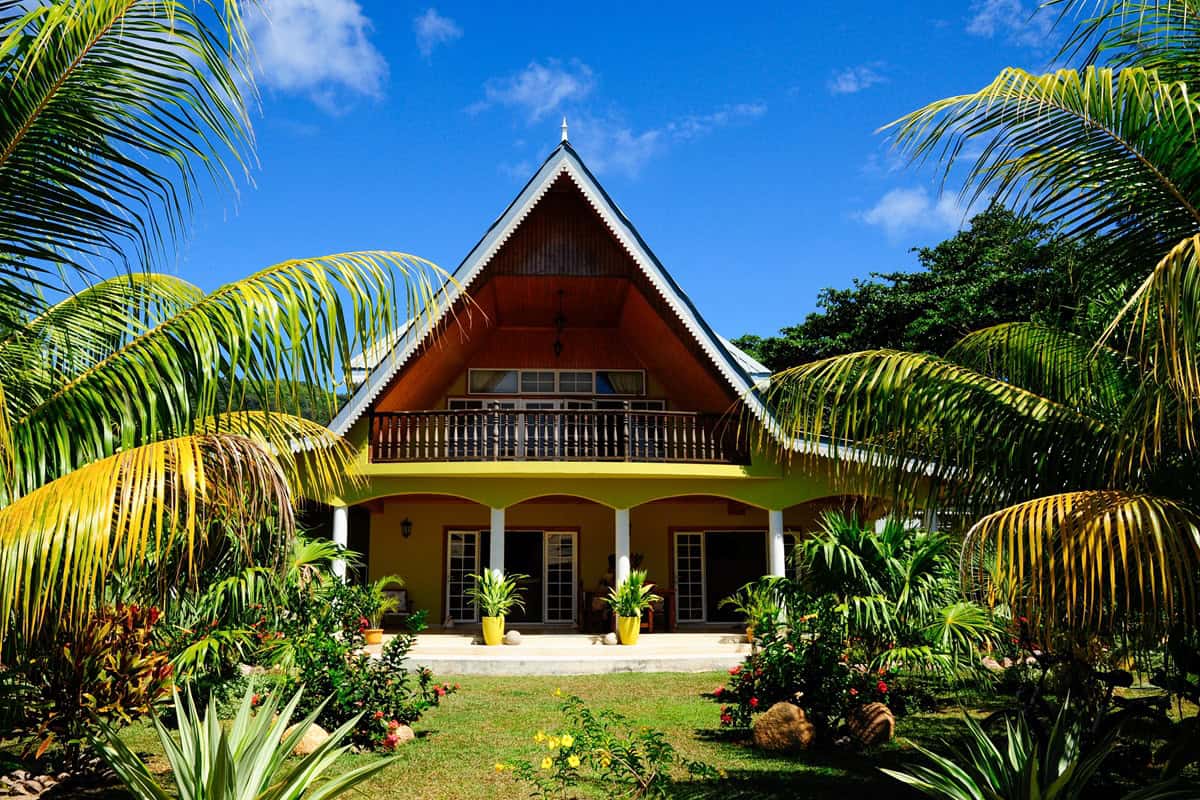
446, 530, 578, 625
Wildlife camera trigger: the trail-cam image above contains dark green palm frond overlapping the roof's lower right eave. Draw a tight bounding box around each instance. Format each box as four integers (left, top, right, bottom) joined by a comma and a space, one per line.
758, 350, 1121, 507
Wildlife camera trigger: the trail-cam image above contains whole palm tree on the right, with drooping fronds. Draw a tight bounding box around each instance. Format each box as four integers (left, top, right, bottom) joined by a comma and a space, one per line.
764, 1, 1200, 632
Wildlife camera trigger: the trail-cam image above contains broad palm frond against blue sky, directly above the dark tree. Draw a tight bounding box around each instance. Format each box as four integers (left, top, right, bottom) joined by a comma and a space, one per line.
887, 67, 1200, 280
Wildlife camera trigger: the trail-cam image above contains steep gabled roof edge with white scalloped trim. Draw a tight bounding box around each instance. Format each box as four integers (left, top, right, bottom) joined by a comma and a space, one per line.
329, 142, 770, 443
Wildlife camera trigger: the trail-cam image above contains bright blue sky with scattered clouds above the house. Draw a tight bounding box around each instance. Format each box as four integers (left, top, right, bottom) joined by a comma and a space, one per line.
178, 0, 1052, 336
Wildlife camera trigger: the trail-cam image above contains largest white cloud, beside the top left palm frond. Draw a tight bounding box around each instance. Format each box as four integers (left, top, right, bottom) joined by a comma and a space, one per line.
247, 0, 388, 112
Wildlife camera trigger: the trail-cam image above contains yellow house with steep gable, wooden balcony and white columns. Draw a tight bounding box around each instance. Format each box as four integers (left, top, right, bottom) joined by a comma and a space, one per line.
330, 137, 873, 630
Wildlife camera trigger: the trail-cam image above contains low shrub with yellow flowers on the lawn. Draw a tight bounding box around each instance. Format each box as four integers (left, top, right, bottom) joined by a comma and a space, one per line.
496, 691, 725, 798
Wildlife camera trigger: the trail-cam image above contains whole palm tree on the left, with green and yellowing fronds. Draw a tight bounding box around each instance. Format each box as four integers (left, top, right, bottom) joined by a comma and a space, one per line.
0, 0, 438, 640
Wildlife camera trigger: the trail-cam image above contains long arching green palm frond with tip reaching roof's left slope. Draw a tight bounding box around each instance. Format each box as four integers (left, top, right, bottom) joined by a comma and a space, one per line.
5, 252, 442, 494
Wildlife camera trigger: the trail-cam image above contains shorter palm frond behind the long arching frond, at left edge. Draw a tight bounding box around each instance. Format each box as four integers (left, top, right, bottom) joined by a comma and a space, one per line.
0, 272, 204, 416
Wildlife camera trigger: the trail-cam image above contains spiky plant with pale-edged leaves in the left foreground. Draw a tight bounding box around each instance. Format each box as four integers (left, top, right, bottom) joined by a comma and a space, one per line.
96, 692, 392, 800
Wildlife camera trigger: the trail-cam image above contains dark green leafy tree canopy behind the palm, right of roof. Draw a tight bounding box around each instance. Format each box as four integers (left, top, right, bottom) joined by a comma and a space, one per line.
734, 205, 1098, 372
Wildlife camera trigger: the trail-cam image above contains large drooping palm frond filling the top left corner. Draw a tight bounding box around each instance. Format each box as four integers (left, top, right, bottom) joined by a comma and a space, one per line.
0, 0, 253, 309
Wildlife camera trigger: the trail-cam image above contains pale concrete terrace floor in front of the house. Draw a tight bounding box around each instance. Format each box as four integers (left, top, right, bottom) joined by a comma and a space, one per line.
367, 631, 750, 675
